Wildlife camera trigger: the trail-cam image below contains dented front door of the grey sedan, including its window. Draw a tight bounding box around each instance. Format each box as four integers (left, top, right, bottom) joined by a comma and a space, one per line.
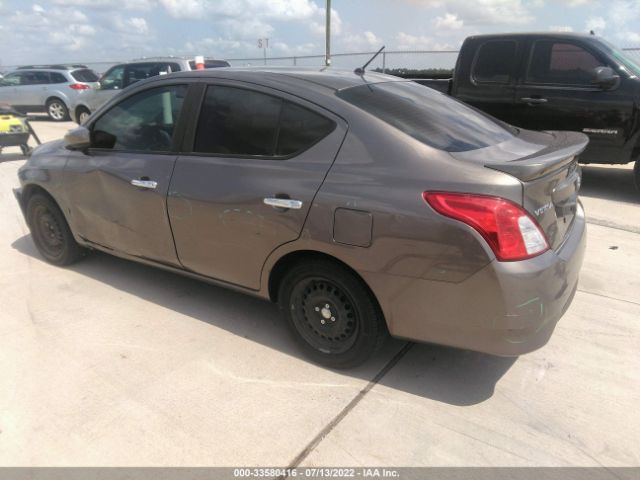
65, 81, 187, 265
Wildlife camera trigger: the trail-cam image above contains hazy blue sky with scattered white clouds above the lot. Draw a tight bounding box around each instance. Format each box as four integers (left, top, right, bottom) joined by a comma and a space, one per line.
0, 0, 640, 67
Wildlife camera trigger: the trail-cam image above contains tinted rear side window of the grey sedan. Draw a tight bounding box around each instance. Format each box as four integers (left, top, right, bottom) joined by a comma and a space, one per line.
194, 86, 335, 157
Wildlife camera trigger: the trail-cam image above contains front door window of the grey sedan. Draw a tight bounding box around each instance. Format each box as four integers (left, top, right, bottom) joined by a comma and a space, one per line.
91, 85, 187, 152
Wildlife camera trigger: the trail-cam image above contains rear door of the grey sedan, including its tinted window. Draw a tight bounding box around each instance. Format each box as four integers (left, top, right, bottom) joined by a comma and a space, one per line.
168, 81, 347, 289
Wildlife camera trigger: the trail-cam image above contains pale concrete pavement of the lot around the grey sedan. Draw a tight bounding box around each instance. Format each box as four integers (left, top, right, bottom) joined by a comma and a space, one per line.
0, 118, 640, 467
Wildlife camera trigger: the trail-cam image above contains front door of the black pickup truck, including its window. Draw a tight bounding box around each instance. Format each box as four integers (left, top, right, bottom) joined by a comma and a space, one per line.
514, 38, 633, 147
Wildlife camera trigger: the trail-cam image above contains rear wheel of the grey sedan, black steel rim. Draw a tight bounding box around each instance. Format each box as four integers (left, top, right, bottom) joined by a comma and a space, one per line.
278, 260, 388, 369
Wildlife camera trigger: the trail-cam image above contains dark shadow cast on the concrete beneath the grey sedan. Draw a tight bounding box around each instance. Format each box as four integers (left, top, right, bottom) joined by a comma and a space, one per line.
12, 235, 517, 406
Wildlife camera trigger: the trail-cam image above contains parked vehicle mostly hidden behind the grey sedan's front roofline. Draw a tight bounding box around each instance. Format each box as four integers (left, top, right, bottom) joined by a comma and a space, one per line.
71, 57, 229, 124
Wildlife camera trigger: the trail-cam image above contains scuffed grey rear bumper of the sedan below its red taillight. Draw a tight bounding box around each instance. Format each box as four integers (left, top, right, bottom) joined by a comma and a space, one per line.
363, 205, 586, 356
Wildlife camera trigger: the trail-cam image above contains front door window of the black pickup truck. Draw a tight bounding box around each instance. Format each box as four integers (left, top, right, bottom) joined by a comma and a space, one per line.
527, 40, 604, 85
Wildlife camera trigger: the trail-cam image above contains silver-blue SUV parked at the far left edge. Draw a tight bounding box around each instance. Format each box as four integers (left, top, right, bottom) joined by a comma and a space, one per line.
0, 65, 98, 122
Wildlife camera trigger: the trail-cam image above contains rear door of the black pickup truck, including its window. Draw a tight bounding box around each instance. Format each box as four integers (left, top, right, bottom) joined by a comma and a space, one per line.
453, 39, 522, 123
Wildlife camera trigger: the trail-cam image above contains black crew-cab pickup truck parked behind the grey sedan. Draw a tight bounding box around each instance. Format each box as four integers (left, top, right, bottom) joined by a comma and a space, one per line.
416, 33, 640, 188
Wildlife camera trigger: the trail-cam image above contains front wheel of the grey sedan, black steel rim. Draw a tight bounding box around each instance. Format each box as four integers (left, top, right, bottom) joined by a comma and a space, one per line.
26, 193, 85, 266
